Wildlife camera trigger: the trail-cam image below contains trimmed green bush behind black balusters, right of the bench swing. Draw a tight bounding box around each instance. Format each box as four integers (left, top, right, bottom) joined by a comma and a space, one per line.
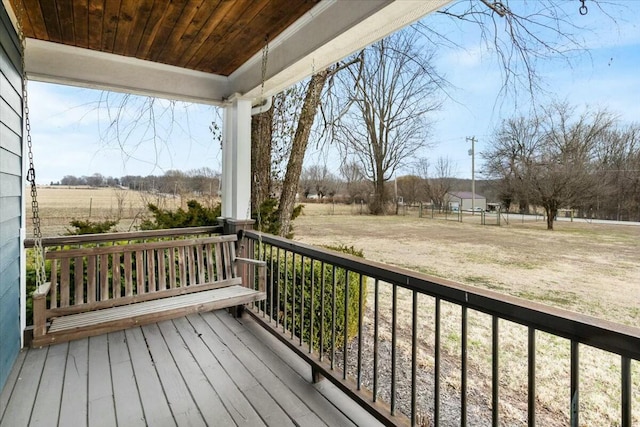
266, 246, 367, 351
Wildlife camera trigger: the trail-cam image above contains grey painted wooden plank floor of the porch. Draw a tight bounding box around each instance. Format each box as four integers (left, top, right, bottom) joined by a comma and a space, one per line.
0, 311, 376, 427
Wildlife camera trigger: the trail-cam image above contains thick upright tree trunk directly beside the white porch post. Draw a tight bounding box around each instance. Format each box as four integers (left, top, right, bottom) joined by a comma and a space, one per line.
251, 107, 273, 213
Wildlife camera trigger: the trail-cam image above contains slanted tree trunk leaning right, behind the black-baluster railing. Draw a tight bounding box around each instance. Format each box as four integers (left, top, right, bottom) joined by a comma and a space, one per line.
279, 70, 331, 236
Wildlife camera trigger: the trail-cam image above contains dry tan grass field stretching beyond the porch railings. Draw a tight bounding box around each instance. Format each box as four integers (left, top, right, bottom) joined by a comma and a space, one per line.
27, 188, 640, 426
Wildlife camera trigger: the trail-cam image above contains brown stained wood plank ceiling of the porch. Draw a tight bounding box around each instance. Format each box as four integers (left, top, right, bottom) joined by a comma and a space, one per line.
10, 0, 319, 76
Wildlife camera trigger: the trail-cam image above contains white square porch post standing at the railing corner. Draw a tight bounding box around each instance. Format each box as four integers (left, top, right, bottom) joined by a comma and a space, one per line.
222, 97, 251, 226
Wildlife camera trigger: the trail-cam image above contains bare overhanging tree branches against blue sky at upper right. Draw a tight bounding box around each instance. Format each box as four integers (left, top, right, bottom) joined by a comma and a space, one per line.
420, 0, 626, 104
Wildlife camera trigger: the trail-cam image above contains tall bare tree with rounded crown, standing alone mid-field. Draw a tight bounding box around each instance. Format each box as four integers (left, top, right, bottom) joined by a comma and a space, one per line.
337, 32, 441, 214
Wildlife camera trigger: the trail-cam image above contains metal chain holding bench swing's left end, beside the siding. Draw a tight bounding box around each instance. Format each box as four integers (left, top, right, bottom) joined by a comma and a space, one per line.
16, 2, 47, 287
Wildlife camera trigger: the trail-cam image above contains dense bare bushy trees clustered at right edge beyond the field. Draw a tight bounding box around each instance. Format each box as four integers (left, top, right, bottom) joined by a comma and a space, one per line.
482, 102, 640, 229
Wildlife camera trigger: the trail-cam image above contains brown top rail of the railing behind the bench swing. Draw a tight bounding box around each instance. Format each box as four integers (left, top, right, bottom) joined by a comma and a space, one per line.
24, 226, 222, 248
